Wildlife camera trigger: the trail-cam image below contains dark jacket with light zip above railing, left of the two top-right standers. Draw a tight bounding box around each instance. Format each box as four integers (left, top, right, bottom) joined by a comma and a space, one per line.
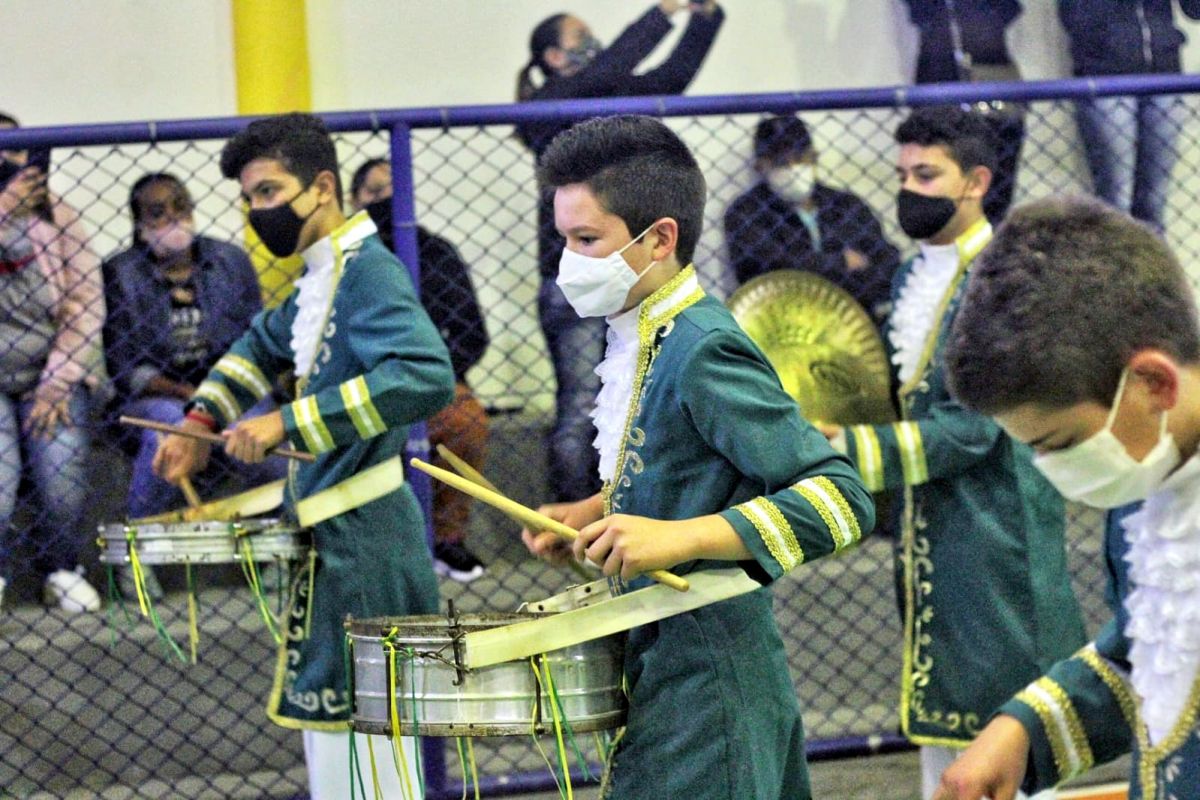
905, 0, 1021, 83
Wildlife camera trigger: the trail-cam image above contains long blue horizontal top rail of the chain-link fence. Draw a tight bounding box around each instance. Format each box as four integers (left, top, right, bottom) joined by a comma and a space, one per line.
7, 74, 1200, 149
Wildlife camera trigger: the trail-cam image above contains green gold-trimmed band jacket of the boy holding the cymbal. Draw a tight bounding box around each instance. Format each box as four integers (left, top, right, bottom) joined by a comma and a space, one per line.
846, 221, 1086, 747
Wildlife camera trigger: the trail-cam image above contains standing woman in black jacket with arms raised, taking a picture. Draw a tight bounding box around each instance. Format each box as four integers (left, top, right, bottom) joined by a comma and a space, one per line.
517, 0, 725, 501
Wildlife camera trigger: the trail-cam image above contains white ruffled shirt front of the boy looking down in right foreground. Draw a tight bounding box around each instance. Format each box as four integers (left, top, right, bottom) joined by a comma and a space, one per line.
1124, 455, 1200, 745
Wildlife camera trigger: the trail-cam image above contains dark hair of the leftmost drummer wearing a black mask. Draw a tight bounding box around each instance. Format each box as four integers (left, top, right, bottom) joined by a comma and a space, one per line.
221, 114, 342, 205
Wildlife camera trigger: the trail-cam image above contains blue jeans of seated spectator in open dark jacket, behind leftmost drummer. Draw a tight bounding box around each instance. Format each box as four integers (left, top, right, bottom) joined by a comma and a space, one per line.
121, 396, 288, 518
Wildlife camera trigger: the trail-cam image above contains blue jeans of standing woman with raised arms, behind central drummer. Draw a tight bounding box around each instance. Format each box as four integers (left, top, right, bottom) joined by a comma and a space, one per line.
538, 278, 607, 503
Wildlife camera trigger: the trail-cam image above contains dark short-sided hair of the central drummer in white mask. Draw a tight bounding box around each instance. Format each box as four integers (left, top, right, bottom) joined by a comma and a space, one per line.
538, 115, 707, 265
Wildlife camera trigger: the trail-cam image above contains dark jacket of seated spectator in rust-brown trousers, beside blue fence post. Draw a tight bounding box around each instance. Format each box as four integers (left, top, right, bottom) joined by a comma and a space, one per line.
416, 225, 487, 383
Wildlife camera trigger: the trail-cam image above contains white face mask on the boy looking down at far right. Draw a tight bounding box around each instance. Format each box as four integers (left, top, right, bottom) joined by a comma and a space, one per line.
1033, 372, 1182, 509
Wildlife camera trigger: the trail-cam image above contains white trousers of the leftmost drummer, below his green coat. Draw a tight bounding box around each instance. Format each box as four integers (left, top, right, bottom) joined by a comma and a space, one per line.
304, 730, 422, 800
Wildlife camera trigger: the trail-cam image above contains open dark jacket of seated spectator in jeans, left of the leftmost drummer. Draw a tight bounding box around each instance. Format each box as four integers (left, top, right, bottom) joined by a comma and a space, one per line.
103, 236, 263, 399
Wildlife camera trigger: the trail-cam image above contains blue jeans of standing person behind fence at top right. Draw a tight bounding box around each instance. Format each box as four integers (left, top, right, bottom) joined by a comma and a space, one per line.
1075, 95, 1180, 233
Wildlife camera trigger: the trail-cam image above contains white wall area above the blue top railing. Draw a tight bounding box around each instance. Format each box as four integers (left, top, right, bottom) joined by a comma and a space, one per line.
0, 0, 1123, 125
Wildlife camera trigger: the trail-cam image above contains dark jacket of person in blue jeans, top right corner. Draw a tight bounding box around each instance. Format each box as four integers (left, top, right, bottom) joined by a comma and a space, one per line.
1058, 0, 1200, 76
